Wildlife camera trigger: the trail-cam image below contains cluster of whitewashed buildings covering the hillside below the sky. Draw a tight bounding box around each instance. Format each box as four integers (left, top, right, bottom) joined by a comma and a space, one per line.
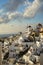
2, 24, 43, 65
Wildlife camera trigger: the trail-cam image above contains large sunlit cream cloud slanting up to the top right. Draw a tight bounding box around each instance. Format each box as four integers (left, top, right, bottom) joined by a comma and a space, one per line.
23, 0, 43, 18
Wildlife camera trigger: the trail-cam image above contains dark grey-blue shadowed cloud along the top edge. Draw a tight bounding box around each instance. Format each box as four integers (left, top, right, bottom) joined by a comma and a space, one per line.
4, 0, 26, 11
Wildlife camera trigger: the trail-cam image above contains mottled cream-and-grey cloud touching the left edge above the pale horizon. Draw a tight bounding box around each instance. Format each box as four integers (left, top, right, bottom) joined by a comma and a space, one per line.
0, 11, 23, 24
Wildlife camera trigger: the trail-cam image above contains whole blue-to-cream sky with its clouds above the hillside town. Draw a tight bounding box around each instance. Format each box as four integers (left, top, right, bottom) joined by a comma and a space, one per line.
0, 0, 43, 34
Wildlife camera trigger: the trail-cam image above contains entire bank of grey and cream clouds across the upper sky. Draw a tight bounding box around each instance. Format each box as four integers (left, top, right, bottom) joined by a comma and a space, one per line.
0, 0, 43, 23
